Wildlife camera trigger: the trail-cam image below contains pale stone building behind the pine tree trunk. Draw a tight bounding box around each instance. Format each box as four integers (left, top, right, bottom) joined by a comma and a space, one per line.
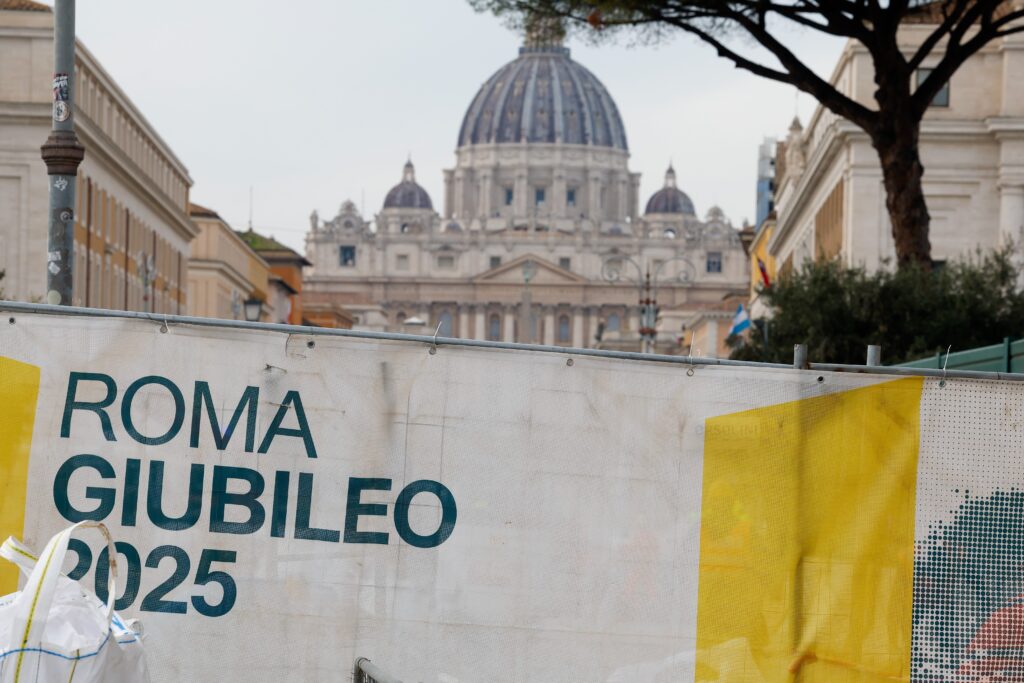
770, 16, 1024, 276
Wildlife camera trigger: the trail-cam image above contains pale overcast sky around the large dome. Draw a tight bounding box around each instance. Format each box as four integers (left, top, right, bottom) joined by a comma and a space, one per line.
68, 0, 842, 251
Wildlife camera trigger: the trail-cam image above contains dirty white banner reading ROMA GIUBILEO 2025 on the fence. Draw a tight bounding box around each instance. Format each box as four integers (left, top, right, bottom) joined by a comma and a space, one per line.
0, 313, 1024, 683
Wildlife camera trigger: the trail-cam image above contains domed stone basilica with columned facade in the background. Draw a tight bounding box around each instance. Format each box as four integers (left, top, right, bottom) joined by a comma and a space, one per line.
303, 34, 748, 352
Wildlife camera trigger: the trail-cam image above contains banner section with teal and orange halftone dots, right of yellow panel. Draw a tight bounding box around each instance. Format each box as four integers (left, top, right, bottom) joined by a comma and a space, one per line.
910, 380, 1024, 683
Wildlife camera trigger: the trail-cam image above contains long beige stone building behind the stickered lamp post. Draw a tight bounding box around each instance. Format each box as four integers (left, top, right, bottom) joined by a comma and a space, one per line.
0, 0, 198, 313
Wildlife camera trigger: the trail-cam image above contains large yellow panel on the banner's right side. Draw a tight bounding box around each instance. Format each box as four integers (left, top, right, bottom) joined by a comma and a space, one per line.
695, 378, 922, 683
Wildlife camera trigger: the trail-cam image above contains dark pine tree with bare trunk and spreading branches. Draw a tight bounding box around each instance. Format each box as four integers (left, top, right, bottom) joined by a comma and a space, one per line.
470, 0, 1024, 265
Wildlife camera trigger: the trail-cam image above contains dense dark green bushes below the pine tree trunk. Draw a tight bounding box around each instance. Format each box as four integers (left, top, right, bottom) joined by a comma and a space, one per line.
728, 248, 1024, 365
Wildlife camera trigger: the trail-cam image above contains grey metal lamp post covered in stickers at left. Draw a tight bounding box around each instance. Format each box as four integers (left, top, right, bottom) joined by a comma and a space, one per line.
40, 0, 85, 306
